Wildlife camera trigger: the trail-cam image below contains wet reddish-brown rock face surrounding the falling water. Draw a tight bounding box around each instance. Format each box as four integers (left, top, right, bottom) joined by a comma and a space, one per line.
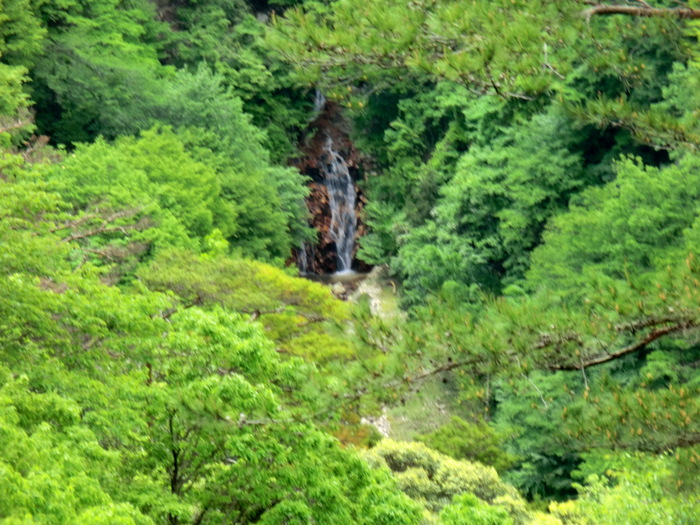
292, 102, 369, 274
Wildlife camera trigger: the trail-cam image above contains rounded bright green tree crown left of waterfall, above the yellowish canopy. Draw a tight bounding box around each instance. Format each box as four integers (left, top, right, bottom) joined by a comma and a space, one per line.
40, 130, 209, 268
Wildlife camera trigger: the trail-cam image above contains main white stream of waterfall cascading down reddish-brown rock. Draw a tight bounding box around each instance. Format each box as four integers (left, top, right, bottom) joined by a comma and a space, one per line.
320, 135, 357, 272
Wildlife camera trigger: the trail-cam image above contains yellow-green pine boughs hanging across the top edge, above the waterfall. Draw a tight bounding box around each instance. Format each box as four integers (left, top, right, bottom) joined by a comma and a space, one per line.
271, 1, 575, 96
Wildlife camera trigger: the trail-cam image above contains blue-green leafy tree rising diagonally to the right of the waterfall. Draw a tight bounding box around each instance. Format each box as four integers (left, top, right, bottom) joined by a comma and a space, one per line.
396, 106, 591, 301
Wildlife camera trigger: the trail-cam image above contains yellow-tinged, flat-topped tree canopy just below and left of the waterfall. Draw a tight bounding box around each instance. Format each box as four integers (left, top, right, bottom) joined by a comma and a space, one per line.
138, 251, 355, 362
